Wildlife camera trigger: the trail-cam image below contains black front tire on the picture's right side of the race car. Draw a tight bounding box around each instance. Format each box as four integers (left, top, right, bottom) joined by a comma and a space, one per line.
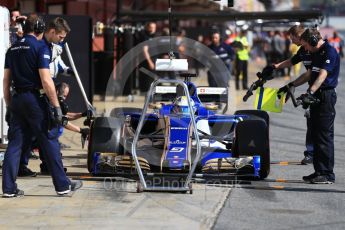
232, 116, 270, 179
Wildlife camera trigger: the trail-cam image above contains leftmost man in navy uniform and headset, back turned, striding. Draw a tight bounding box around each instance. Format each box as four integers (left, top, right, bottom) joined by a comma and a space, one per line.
2, 16, 82, 198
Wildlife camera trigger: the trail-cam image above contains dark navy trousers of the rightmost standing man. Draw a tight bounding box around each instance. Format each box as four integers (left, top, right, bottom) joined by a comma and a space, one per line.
310, 89, 337, 180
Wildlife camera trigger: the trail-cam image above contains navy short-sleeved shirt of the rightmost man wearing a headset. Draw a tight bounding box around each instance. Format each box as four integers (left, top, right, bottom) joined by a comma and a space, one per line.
311, 41, 340, 89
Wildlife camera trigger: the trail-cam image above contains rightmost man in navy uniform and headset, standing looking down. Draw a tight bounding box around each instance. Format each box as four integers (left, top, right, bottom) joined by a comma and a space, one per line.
280, 29, 340, 184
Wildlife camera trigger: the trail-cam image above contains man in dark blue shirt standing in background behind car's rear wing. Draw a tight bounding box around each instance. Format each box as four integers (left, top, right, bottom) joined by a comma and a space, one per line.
207, 30, 235, 87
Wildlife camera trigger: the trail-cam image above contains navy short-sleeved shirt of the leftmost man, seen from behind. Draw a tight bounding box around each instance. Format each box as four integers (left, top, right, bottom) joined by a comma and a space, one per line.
5, 35, 51, 89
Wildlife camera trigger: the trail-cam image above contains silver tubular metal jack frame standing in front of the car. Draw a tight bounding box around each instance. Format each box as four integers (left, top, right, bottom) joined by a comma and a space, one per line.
131, 79, 201, 194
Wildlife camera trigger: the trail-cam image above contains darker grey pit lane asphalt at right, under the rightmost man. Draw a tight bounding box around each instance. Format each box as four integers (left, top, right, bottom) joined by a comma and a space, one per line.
213, 61, 345, 230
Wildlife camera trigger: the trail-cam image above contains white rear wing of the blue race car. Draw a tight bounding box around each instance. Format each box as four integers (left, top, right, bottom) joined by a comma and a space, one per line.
153, 86, 229, 113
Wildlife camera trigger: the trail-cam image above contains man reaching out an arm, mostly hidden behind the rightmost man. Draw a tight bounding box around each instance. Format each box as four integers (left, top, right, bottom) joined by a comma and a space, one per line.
263, 25, 314, 165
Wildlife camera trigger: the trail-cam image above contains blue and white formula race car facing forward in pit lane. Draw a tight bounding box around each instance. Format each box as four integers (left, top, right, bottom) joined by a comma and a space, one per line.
87, 74, 270, 191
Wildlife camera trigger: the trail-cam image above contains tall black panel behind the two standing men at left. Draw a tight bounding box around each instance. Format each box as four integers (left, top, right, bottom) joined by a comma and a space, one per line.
44, 15, 93, 112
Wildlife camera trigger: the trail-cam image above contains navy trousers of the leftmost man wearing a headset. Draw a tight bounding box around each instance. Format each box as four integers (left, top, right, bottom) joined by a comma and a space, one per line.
2, 92, 71, 193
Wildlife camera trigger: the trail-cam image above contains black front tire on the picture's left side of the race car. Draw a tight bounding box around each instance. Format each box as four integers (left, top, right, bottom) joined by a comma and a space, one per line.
87, 117, 124, 173
